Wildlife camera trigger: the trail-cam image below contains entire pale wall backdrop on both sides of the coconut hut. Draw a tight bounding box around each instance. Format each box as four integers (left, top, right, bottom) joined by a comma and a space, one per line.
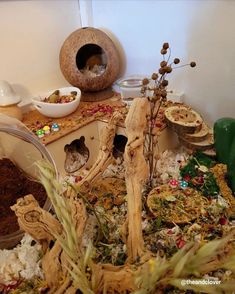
0, 0, 235, 123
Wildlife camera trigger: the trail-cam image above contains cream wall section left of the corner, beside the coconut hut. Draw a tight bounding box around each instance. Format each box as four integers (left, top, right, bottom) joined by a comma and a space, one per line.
0, 0, 81, 100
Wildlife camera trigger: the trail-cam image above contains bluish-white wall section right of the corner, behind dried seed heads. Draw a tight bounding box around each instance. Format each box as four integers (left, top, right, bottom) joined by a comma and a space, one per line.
89, 0, 235, 123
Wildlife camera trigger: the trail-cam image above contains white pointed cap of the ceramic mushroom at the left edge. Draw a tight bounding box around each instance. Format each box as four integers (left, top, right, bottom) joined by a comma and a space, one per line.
0, 80, 21, 106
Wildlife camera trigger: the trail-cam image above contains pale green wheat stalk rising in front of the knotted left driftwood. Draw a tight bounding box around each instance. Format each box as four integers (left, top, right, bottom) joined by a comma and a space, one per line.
37, 160, 94, 294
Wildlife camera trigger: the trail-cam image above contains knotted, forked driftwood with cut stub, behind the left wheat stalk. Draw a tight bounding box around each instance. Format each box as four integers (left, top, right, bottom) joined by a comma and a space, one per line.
11, 195, 87, 294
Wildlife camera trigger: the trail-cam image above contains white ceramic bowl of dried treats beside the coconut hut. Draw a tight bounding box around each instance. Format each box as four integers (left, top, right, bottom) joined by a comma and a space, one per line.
32, 87, 81, 118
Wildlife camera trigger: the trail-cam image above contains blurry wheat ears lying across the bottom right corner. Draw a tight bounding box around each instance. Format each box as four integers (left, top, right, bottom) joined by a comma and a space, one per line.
134, 232, 235, 294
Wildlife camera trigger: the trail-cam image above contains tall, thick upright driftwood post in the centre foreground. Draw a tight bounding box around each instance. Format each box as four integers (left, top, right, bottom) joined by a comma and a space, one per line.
124, 98, 148, 262
